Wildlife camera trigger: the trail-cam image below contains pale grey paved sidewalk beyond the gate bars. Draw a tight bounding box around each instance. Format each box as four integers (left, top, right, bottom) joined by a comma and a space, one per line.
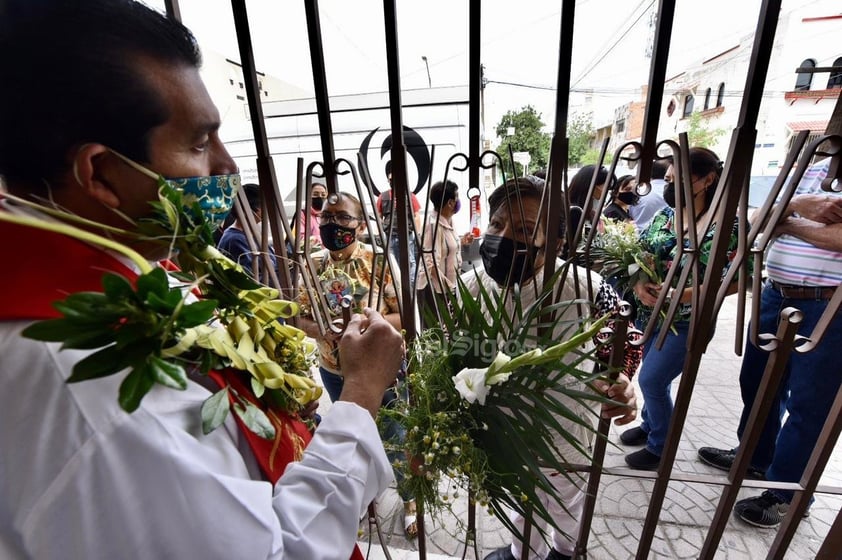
322, 297, 842, 560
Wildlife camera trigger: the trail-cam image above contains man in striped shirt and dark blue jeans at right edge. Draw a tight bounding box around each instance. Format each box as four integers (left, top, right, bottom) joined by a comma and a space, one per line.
699, 159, 842, 527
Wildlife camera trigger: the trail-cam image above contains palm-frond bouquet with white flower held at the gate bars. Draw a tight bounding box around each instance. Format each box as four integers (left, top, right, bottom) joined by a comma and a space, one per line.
381, 275, 607, 534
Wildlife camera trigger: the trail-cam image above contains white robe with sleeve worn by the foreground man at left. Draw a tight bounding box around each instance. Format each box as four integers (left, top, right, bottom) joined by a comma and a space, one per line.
0, 323, 392, 560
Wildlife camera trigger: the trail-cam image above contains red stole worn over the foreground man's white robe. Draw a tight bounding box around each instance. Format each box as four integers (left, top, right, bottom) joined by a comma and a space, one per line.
0, 220, 363, 560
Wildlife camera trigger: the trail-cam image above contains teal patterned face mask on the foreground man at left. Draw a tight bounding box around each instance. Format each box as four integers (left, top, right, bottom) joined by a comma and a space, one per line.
111, 150, 240, 229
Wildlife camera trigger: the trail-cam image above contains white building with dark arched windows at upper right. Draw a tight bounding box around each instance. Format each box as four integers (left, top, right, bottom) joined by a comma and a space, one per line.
658, 0, 842, 175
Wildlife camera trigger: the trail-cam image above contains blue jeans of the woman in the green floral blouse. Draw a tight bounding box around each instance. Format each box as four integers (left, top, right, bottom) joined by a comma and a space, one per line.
637, 321, 690, 457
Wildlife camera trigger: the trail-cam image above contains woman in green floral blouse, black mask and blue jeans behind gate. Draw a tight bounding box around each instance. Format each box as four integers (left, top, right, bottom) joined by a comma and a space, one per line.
620, 148, 737, 470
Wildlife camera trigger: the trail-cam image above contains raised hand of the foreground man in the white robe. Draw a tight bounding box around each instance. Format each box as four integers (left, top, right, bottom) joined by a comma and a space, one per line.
339, 308, 405, 417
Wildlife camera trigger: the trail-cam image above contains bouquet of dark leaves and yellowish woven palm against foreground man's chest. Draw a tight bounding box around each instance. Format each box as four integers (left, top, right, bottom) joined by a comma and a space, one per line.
0, 180, 321, 440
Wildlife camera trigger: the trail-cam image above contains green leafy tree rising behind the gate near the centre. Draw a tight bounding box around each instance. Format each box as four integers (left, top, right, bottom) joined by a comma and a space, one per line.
495, 105, 550, 176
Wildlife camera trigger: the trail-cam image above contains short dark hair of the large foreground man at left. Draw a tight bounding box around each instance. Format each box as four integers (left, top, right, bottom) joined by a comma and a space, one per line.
0, 0, 201, 188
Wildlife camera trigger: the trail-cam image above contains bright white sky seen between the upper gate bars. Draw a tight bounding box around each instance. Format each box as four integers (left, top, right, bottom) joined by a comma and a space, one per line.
143, 0, 776, 136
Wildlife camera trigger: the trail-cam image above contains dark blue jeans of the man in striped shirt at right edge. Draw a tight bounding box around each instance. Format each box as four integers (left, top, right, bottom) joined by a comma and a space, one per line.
737, 287, 842, 502
